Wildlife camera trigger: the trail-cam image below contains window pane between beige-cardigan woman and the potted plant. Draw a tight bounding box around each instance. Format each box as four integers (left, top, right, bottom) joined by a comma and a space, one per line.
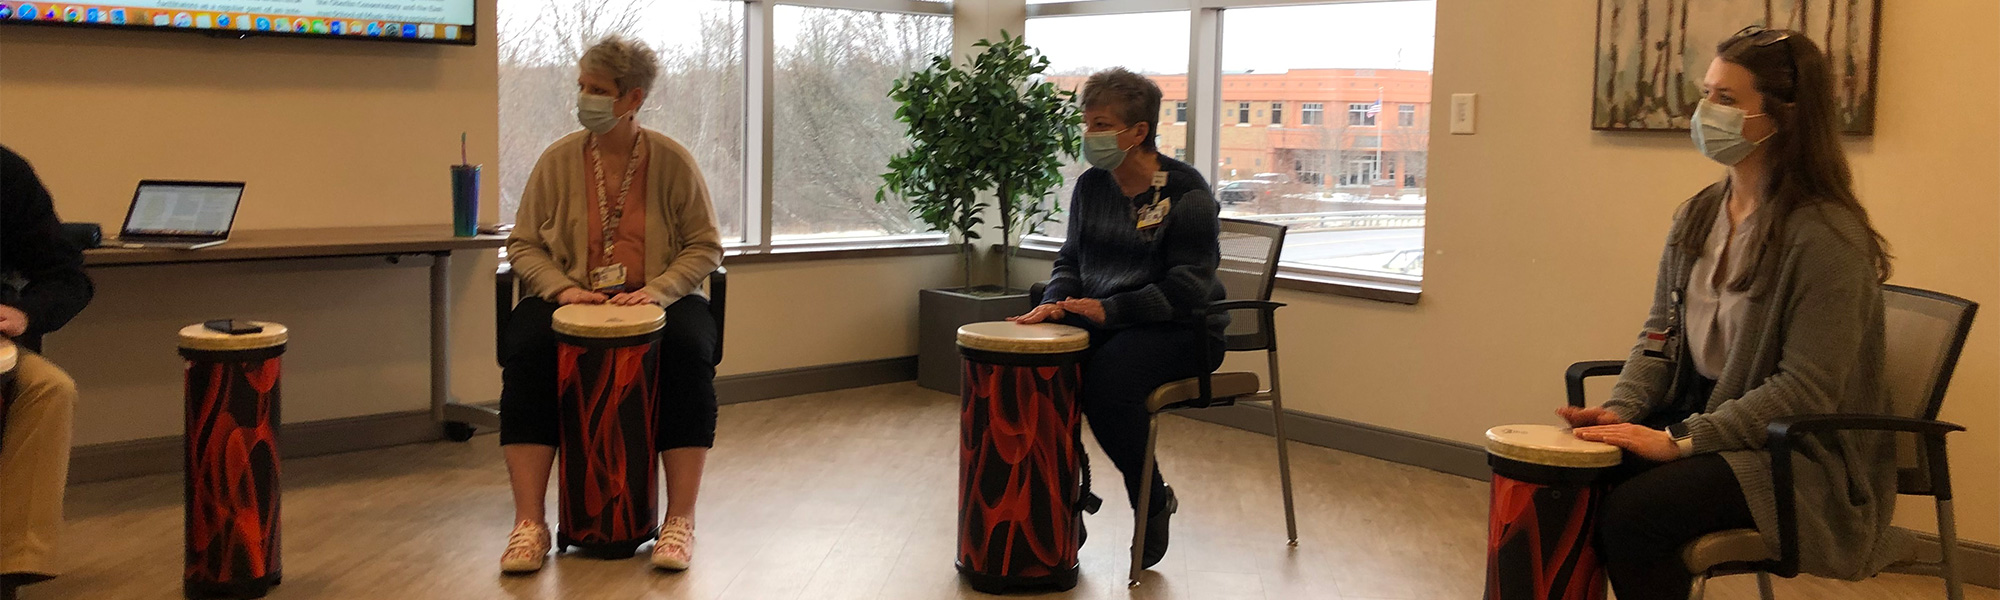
768, 0, 952, 242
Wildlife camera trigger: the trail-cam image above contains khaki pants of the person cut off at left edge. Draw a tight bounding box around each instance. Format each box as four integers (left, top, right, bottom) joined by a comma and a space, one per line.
0, 352, 76, 576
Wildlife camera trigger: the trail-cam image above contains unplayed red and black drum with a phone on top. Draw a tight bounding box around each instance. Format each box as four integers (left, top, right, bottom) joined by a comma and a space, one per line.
180, 322, 288, 598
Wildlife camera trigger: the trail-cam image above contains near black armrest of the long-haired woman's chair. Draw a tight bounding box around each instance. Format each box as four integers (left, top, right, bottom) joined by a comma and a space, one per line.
1764, 414, 1966, 578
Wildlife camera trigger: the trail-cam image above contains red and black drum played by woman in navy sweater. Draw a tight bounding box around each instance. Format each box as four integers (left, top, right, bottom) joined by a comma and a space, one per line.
958, 322, 1090, 594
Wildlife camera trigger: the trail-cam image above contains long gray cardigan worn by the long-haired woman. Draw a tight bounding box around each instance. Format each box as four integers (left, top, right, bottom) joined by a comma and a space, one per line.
1604, 184, 1908, 580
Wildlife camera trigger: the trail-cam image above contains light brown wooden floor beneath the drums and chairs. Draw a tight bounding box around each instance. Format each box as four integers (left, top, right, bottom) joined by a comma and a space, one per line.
35, 384, 2000, 600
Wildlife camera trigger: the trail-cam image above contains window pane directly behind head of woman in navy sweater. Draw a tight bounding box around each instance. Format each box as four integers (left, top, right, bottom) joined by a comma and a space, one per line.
1026, 12, 1188, 238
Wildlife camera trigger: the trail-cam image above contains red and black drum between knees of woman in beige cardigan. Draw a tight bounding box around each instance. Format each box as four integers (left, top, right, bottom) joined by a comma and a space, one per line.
554, 304, 666, 558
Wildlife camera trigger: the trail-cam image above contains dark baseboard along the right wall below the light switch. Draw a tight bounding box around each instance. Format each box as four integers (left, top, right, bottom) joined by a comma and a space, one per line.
1176, 404, 2000, 588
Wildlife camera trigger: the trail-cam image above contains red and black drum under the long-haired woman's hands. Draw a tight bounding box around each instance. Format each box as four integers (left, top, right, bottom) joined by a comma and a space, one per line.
1486, 424, 1622, 600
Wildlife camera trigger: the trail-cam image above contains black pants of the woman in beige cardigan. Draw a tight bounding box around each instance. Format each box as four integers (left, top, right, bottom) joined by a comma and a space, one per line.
500, 296, 716, 450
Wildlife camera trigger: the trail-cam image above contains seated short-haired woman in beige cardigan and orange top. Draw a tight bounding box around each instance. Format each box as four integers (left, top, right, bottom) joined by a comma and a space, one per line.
500, 38, 722, 572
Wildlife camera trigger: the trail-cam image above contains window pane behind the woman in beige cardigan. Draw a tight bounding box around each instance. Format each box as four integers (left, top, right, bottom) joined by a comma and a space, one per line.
490, 0, 746, 242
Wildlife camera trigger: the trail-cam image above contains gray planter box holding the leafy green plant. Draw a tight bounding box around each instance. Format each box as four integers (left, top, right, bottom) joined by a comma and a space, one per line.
916, 288, 1034, 394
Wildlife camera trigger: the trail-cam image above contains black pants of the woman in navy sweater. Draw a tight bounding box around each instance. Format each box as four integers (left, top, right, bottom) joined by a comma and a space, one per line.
1064, 316, 1222, 514
